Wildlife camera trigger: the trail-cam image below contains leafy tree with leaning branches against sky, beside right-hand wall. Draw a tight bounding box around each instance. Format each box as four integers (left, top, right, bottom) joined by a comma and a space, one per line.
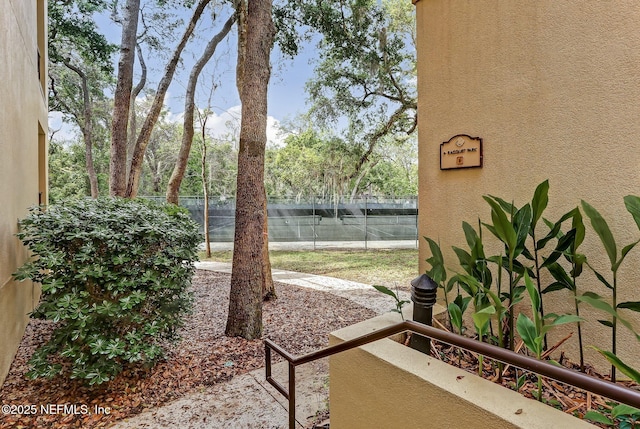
275, 0, 417, 185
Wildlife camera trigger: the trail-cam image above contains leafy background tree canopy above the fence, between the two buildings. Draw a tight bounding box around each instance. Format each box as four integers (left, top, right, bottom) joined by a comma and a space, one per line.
48, 0, 417, 198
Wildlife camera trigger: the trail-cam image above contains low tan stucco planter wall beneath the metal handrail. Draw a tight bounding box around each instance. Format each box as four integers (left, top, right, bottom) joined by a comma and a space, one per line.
329, 313, 594, 429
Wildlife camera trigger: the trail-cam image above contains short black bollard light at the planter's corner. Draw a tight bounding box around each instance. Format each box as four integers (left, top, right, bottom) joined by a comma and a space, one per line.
409, 274, 438, 354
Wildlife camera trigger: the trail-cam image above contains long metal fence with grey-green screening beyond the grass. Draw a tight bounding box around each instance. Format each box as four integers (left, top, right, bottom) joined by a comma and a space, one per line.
150, 196, 418, 246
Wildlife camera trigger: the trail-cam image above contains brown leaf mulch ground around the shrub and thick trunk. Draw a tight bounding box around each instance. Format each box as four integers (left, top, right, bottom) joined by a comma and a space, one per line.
0, 271, 375, 429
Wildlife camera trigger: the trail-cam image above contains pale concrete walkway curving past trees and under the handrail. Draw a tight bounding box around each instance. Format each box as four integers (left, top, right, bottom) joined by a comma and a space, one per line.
112, 262, 409, 429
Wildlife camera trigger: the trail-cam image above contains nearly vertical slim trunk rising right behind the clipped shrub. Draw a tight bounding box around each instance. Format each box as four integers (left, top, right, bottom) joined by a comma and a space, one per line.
109, 0, 140, 197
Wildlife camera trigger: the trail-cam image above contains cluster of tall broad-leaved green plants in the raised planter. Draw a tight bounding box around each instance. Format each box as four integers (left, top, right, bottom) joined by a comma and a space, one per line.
425, 181, 640, 416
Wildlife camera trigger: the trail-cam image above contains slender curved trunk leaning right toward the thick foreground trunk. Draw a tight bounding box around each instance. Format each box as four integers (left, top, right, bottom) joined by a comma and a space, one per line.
167, 14, 236, 204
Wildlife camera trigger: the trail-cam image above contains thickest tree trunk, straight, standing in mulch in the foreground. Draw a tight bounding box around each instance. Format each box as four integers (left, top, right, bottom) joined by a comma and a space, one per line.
225, 0, 275, 339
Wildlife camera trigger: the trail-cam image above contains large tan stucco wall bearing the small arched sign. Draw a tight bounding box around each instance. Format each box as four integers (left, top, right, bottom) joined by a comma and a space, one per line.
416, 0, 640, 368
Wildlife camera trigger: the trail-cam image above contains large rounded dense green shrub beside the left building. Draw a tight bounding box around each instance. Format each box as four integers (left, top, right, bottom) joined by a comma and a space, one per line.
14, 198, 201, 385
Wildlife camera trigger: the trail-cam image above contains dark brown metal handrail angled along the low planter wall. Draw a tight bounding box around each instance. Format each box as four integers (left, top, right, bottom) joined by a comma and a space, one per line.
264, 320, 640, 429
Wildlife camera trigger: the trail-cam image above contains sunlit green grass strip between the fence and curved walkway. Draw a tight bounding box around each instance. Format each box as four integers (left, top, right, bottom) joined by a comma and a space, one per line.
201, 249, 419, 289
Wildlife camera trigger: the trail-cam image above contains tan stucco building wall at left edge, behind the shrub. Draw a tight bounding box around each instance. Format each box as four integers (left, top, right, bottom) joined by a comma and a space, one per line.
0, 0, 47, 385
